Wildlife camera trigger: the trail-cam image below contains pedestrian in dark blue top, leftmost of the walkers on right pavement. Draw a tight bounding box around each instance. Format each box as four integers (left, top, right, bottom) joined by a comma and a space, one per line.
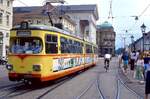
122, 51, 129, 74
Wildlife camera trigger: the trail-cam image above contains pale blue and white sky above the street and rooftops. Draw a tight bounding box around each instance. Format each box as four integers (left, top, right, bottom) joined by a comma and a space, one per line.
13, 0, 150, 49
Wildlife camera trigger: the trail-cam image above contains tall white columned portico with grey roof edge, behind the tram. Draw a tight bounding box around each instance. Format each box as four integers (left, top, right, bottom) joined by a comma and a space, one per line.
60, 4, 99, 44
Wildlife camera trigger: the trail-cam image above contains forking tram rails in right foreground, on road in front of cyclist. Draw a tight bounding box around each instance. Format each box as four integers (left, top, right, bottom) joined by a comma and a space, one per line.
75, 62, 143, 99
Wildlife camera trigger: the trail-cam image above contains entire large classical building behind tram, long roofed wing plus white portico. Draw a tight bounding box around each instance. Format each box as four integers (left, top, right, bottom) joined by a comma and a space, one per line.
13, 5, 98, 44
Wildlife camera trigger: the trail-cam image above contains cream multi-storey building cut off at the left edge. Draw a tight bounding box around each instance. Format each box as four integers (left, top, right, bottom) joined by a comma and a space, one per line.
0, 0, 13, 58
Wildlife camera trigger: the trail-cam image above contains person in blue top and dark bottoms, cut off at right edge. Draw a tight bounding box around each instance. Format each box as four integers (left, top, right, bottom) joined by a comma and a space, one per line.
144, 55, 150, 99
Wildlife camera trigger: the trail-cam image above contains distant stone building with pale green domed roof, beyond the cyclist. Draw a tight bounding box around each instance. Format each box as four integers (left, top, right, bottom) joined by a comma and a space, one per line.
96, 21, 116, 56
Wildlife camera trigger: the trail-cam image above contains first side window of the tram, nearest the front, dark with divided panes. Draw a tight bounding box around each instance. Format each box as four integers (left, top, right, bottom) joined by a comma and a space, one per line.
45, 35, 58, 54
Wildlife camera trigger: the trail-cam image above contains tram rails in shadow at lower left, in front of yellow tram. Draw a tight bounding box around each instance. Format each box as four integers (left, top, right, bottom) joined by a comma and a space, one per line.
0, 77, 73, 99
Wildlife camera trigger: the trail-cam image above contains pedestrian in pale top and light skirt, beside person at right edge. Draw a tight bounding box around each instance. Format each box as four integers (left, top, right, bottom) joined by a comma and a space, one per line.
135, 55, 144, 84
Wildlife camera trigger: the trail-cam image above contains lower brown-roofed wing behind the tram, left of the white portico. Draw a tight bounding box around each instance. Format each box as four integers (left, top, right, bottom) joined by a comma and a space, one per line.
13, 6, 76, 34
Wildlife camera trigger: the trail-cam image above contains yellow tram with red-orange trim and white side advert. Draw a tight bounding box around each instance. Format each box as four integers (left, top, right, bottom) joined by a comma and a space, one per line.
6, 22, 97, 82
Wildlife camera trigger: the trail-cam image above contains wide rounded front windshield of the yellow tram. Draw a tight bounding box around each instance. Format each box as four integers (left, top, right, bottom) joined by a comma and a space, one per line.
10, 37, 42, 54
